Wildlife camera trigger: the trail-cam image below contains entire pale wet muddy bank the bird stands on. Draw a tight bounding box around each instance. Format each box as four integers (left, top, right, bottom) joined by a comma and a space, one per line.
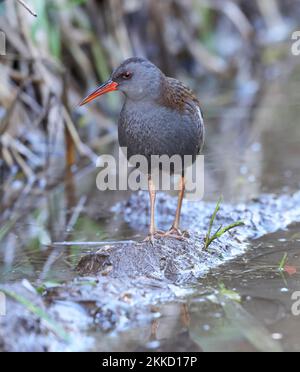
0, 193, 300, 351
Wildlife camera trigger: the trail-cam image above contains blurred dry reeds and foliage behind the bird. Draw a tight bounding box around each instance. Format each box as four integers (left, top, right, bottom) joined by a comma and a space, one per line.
0, 0, 300, 205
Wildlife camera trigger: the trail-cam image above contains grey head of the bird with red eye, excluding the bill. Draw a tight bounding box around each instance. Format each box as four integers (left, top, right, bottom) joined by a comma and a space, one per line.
111, 58, 163, 101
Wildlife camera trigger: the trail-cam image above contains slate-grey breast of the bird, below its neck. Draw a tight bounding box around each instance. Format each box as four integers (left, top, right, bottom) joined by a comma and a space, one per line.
119, 102, 203, 160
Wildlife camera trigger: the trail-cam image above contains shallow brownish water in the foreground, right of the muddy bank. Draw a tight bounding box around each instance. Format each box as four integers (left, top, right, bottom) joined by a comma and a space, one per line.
130, 225, 300, 351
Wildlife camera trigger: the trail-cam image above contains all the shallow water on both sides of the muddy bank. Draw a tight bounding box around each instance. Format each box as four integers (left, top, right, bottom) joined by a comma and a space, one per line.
0, 58, 300, 351
